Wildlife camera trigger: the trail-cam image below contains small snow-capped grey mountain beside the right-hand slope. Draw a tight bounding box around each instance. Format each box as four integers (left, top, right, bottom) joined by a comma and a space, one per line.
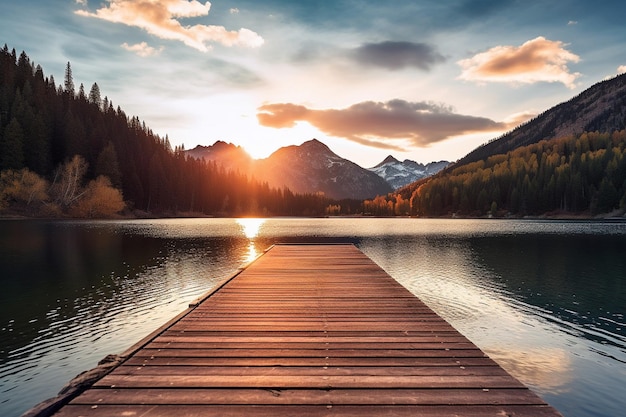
369, 155, 450, 190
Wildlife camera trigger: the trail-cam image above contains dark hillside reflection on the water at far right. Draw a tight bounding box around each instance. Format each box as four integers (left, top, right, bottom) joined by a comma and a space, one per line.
472, 235, 626, 352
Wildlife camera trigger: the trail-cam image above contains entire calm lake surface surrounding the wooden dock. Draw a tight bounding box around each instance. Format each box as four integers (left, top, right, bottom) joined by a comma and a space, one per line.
0, 219, 626, 417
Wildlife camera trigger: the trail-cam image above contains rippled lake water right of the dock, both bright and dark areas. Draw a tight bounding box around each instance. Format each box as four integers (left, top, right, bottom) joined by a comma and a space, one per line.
361, 228, 626, 417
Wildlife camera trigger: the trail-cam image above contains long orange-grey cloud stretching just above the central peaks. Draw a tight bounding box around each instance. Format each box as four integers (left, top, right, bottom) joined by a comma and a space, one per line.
257, 99, 521, 150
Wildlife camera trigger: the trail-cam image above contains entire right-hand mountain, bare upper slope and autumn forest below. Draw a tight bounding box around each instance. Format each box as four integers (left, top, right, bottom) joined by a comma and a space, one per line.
392, 74, 626, 217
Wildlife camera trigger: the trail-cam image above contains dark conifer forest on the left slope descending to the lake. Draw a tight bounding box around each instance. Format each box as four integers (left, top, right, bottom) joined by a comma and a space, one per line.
0, 45, 361, 216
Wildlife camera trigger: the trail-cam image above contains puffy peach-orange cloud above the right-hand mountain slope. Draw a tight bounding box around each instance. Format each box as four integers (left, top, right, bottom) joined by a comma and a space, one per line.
458, 36, 580, 88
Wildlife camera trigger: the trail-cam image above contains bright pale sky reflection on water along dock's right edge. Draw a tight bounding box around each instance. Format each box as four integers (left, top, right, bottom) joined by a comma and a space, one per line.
362, 236, 572, 394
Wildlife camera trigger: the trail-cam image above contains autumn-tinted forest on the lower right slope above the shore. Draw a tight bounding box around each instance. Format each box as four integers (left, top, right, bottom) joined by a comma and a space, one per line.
365, 130, 626, 216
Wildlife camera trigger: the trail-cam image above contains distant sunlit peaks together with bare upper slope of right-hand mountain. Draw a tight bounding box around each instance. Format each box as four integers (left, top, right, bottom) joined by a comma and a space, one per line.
186, 74, 626, 206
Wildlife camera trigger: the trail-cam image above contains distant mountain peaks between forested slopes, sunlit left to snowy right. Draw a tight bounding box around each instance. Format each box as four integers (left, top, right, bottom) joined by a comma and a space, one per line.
186, 139, 449, 200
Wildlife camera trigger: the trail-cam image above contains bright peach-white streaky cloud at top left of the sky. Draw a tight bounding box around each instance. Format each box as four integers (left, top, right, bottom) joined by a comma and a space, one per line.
75, 0, 264, 52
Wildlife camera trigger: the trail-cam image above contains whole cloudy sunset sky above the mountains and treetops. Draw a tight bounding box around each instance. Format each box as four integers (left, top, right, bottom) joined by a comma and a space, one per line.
0, 0, 626, 168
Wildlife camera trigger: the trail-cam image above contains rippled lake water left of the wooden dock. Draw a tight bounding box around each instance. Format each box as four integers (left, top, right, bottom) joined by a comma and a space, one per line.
0, 222, 247, 416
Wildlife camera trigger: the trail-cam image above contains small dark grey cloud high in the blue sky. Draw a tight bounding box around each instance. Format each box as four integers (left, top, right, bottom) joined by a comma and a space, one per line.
353, 41, 445, 70
